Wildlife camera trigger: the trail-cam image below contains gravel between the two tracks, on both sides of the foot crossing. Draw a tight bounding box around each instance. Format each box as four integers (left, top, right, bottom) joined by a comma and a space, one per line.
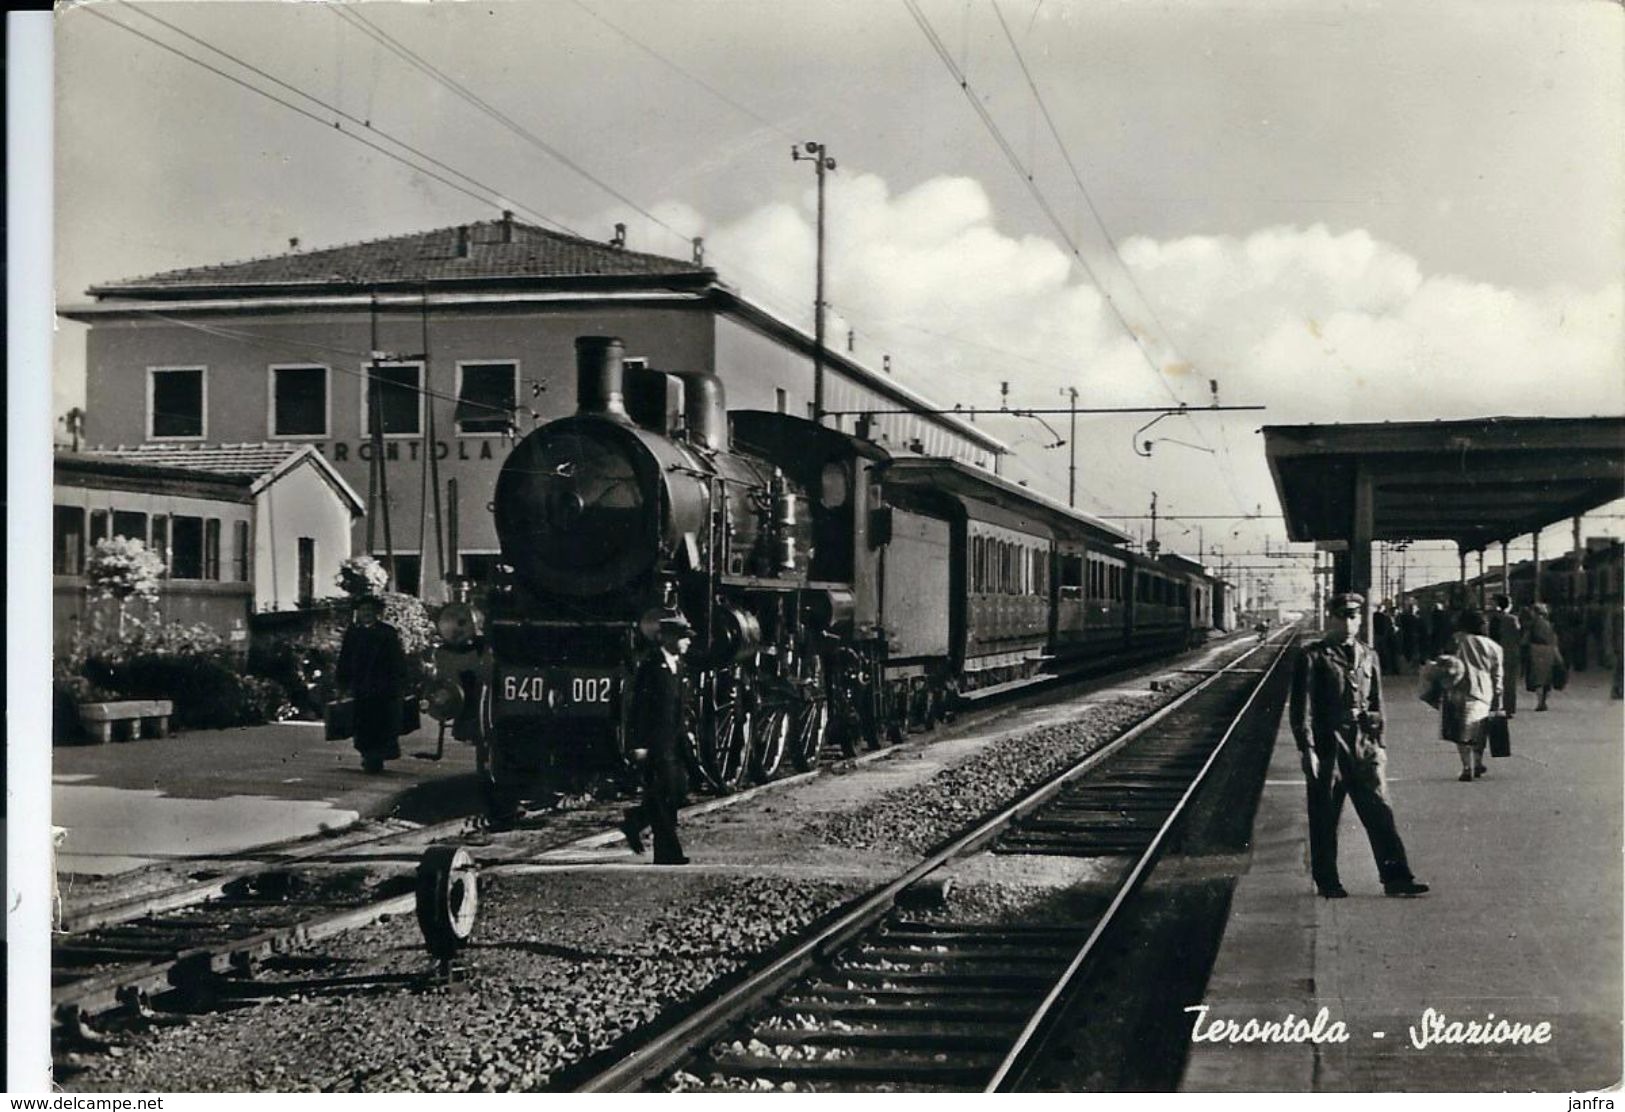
57, 656, 1228, 1092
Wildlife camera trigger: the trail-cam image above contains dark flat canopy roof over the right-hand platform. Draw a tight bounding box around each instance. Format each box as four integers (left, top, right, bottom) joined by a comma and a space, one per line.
1264, 416, 1625, 551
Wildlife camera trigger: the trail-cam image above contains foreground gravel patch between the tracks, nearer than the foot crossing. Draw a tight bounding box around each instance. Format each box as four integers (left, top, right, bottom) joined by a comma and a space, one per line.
59, 875, 855, 1092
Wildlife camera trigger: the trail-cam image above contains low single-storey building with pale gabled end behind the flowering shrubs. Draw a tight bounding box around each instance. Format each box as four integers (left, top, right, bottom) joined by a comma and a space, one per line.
52, 444, 362, 649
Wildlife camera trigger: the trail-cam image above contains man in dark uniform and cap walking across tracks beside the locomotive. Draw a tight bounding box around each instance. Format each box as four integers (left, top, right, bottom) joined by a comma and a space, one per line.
621, 615, 694, 865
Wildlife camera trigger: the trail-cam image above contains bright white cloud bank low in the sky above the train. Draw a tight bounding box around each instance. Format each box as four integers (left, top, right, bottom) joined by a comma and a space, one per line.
581, 169, 1625, 540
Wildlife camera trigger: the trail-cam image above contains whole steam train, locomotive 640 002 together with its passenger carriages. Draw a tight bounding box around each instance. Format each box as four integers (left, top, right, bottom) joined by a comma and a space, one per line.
458, 337, 1214, 793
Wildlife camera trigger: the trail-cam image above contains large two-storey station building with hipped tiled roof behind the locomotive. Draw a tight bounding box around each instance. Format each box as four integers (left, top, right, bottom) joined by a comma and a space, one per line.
62, 215, 1006, 592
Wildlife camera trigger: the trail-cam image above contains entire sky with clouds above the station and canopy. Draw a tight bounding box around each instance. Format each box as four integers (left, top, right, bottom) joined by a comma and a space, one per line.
54, 0, 1625, 595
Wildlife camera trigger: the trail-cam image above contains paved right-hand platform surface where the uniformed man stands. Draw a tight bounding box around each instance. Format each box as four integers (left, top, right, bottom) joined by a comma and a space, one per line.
1180, 650, 1625, 1092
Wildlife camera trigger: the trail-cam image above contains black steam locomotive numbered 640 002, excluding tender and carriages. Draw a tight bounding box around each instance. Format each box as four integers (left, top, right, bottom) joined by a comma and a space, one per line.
486, 337, 852, 803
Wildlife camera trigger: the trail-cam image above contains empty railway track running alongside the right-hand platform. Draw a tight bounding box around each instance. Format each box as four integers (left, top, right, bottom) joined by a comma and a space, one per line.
570, 637, 1290, 1092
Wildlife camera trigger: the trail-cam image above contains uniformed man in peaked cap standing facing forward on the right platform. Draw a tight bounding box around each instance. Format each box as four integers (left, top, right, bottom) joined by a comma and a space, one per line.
1290, 593, 1428, 899
